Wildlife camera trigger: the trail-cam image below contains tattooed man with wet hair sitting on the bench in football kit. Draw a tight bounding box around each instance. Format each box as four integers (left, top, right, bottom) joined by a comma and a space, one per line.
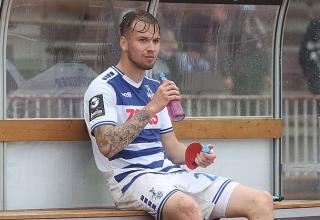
84, 11, 273, 220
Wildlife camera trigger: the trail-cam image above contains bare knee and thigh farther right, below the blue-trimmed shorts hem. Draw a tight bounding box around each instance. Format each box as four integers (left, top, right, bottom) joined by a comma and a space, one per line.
226, 184, 274, 220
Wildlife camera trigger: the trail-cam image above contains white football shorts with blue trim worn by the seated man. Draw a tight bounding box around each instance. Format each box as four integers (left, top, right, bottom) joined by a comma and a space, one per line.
111, 171, 238, 219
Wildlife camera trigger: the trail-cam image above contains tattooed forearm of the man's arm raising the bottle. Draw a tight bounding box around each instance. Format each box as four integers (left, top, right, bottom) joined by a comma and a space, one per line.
94, 109, 151, 158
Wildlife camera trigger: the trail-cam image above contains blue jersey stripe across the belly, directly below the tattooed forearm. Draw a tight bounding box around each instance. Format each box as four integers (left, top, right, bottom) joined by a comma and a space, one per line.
109, 147, 163, 161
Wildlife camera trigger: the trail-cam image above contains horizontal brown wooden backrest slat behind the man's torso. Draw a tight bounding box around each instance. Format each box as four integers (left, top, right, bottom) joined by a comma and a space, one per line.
0, 118, 283, 142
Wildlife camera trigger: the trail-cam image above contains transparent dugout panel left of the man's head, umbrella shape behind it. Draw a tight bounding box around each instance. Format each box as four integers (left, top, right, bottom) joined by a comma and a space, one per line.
6, 0, 148, 118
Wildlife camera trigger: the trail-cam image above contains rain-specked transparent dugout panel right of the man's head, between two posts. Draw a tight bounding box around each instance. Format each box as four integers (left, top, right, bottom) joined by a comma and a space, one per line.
153, 2, 279, 117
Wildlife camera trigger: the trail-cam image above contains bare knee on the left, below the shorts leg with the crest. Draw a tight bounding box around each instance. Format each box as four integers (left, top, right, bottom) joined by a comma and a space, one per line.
162, 192, 203, 220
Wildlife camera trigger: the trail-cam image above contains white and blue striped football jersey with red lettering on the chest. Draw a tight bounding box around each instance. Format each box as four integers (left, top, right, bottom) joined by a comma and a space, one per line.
84, 66, 183, 193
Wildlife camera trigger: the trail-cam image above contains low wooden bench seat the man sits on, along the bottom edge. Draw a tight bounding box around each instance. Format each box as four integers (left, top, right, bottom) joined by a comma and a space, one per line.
0, 200, 320, 220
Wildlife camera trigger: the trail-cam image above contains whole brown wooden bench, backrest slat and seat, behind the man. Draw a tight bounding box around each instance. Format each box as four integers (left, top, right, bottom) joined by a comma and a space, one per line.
0, 119, 320, 220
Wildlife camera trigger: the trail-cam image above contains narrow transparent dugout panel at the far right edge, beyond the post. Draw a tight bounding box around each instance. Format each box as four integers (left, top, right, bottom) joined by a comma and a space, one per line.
282, 0, 320, 199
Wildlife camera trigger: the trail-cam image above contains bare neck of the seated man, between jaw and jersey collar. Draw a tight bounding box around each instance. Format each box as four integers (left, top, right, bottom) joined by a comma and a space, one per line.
116, 55, 145, 83
